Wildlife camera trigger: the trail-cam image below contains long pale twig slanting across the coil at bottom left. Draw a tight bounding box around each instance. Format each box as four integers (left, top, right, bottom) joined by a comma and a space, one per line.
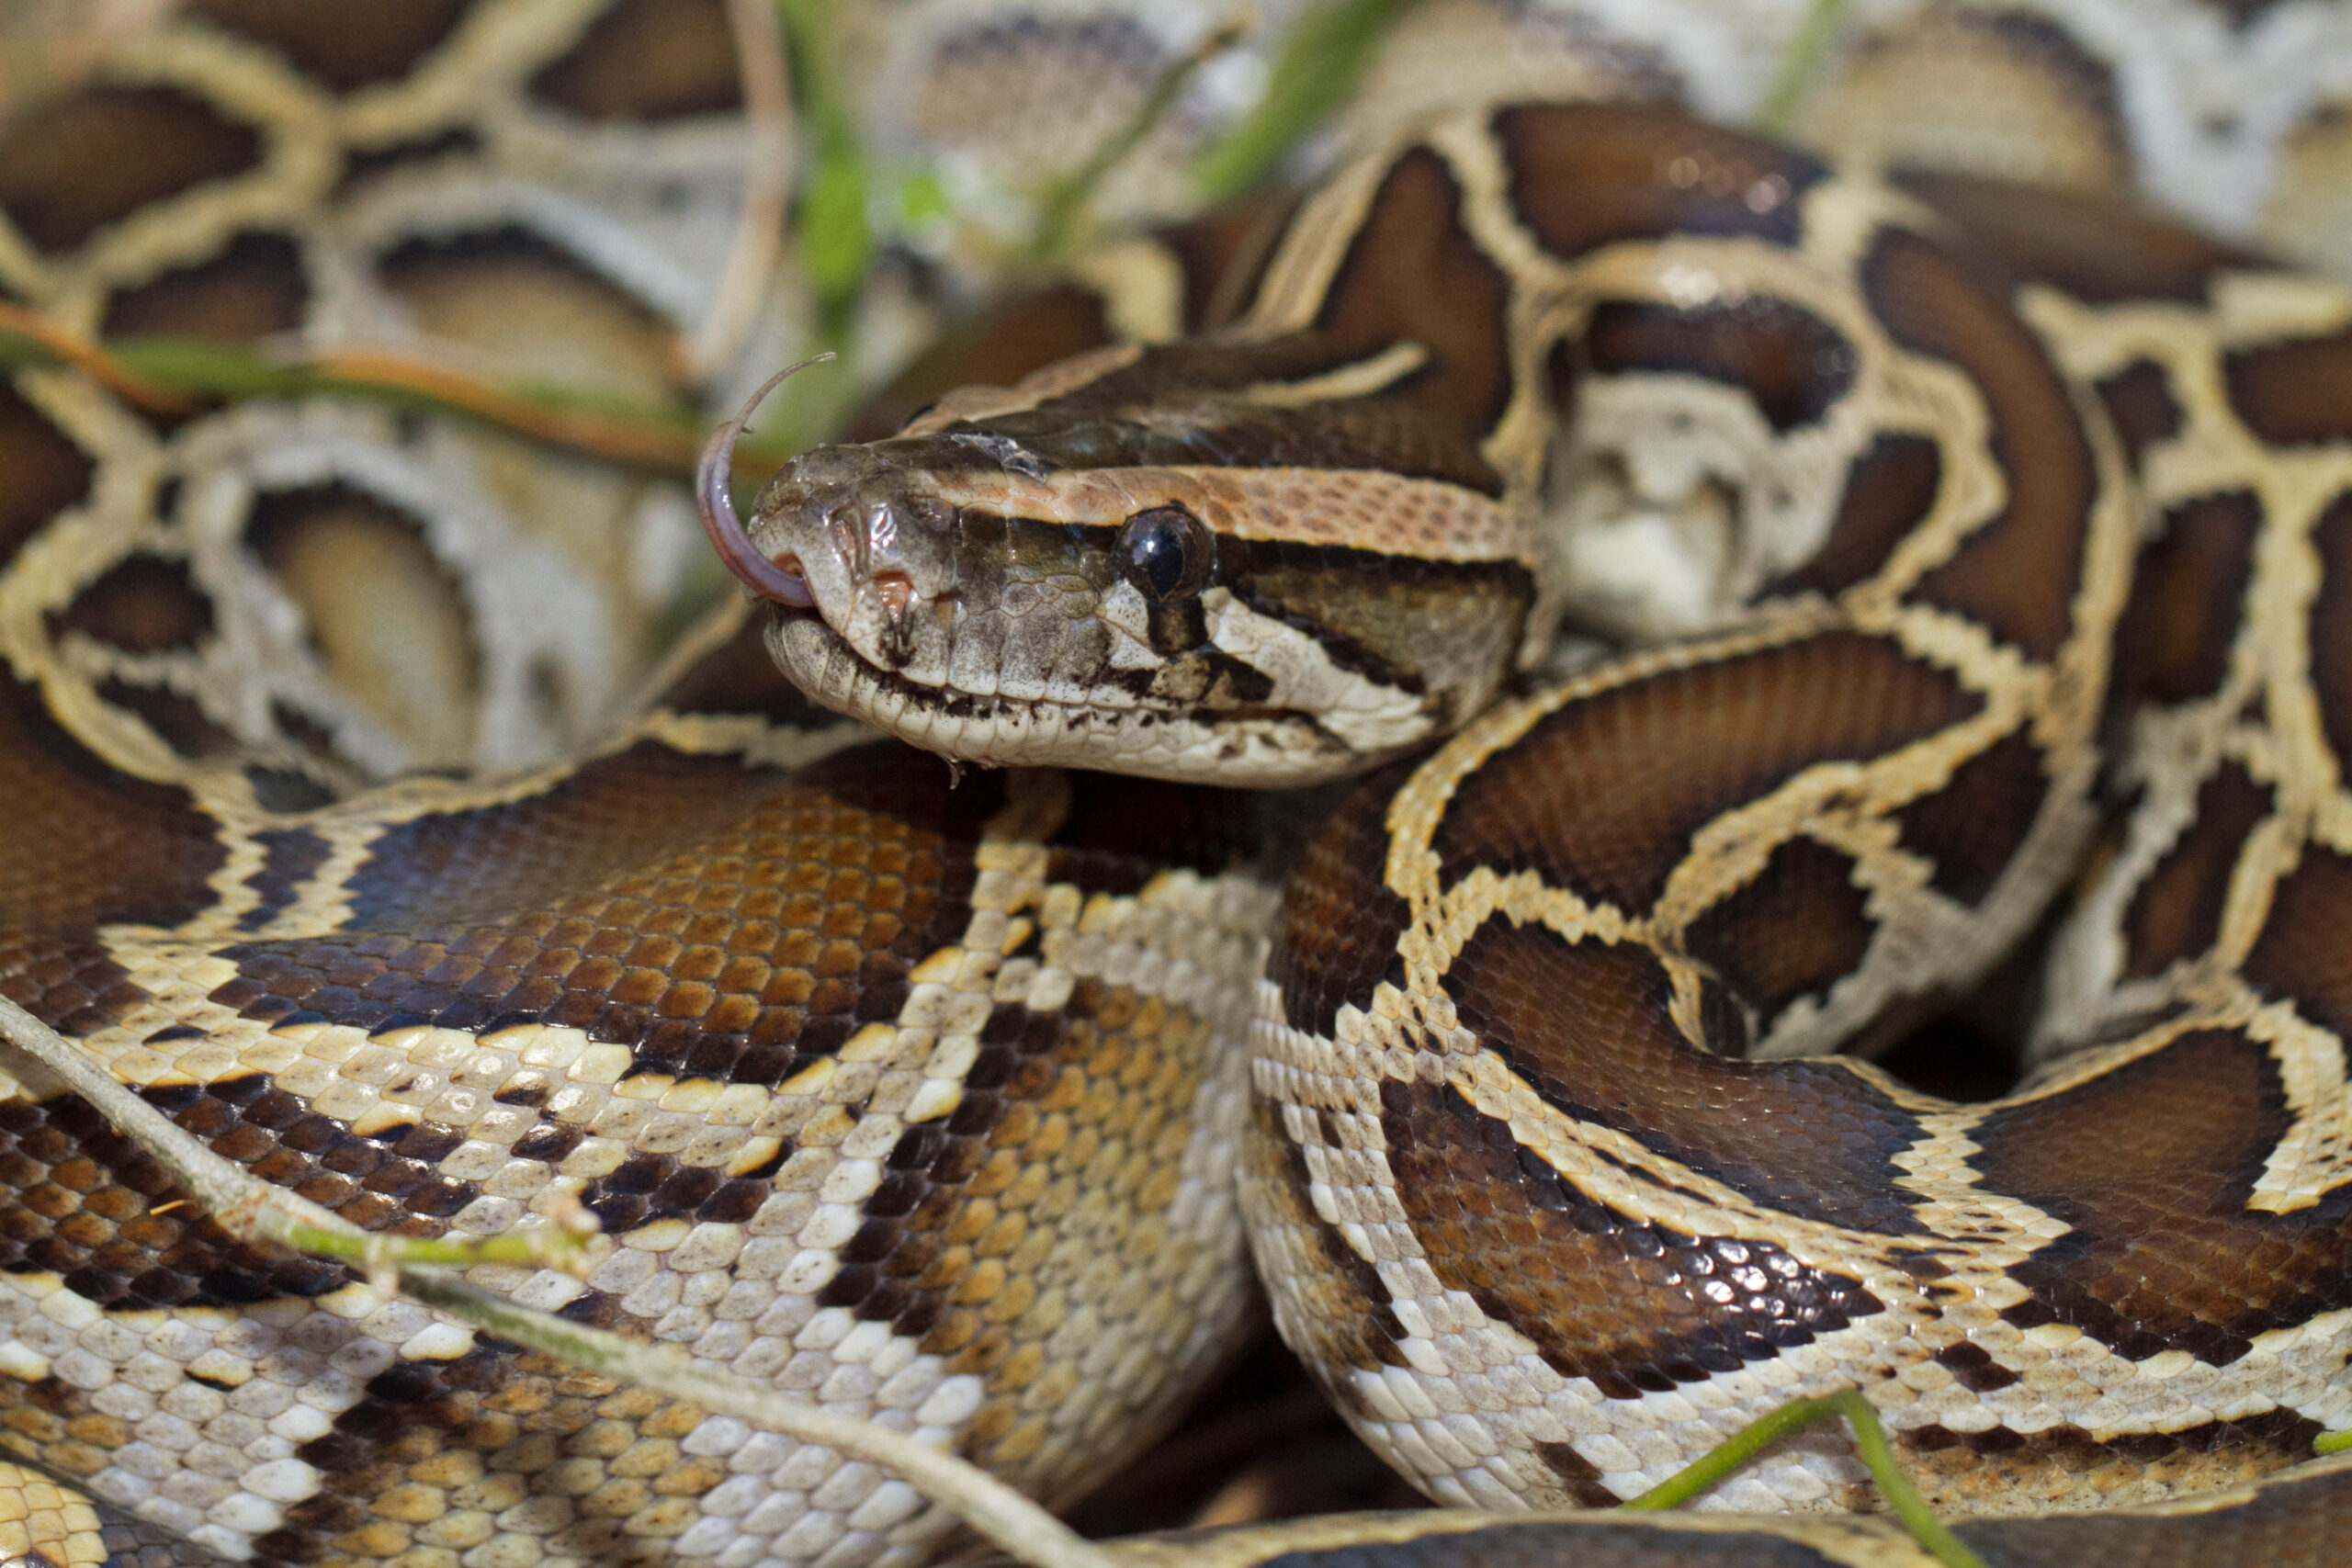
0, 997, 1110, 1568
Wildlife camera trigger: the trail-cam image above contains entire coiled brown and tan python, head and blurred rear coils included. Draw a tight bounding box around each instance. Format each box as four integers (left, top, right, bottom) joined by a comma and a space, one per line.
14, 0, 2352, 1568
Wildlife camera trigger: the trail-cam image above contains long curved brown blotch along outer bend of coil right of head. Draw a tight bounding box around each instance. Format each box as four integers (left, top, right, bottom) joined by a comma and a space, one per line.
1863, 231, 2098, 660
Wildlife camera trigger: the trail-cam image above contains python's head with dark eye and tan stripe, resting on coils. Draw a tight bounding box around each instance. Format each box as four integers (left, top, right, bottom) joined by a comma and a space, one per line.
706, 345, 1536, 785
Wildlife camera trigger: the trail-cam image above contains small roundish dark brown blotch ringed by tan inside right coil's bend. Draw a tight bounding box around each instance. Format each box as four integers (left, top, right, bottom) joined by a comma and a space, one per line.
1681, 840, 1877, 1030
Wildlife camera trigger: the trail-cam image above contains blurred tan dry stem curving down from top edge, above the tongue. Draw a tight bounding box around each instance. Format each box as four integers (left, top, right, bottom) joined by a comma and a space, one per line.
687, 0, 793, 381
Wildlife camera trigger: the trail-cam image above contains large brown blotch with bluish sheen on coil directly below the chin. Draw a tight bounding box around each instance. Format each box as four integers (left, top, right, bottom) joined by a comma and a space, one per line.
214, 740, 1002, 1084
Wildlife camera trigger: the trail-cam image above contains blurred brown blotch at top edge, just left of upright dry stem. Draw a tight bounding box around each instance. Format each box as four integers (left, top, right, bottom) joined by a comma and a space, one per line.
532, 0, 743, 122
